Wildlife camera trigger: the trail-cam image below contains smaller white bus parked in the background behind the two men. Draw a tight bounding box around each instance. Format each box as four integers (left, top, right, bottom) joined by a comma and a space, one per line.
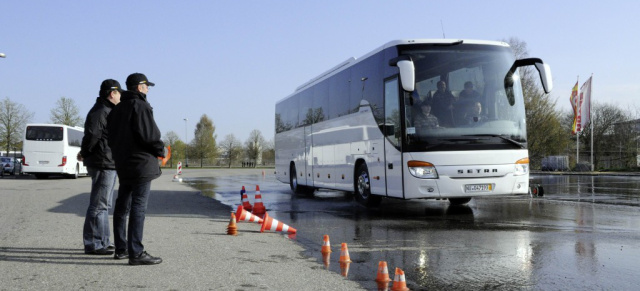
22, 124, 87, 179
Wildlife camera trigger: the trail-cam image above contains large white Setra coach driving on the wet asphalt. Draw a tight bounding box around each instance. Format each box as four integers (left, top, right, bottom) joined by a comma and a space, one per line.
275, 39, 552, 206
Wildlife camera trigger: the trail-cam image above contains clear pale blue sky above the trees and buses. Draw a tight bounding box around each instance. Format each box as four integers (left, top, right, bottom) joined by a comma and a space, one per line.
0, 0, 640, 142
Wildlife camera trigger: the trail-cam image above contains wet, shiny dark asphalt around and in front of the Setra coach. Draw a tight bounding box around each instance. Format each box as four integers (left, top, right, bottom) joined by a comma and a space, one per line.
189, 175, 640, 290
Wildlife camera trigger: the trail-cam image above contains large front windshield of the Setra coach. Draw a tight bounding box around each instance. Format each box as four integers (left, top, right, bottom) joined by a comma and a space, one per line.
399, 44, 527, 151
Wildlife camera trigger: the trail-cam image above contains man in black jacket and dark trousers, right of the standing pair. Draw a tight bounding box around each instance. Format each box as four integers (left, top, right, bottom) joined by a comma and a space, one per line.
107, 73, 164, 265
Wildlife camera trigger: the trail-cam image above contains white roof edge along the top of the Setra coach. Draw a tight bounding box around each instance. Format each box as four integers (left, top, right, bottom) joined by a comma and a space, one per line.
277, 39, 509, 103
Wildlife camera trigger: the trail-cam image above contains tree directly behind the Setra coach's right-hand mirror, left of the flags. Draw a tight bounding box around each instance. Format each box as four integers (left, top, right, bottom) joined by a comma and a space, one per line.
505, 37, 570, 168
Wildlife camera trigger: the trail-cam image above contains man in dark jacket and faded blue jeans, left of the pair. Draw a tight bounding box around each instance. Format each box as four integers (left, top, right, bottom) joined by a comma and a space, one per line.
78, 79, 122, 255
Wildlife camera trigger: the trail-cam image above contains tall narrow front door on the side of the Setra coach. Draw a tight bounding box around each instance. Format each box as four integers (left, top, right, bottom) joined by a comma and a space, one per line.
383, 76, 403, 197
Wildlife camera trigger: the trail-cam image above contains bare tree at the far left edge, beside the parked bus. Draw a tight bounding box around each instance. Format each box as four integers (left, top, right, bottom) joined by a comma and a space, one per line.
0, 97, 33, 155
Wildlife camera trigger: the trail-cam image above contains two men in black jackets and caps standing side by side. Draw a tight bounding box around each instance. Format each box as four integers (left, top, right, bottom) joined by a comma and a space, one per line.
78, 73, 164, 265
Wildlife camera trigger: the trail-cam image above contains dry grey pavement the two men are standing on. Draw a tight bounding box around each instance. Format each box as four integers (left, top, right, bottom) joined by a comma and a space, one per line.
0, 169, 361, 290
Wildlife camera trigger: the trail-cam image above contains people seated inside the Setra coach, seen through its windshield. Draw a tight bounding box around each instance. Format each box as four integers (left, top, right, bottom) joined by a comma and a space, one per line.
413, 81, 487, 128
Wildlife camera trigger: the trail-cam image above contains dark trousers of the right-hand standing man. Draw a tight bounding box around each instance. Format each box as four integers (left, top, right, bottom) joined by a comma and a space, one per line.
113, 181, 151, 258
